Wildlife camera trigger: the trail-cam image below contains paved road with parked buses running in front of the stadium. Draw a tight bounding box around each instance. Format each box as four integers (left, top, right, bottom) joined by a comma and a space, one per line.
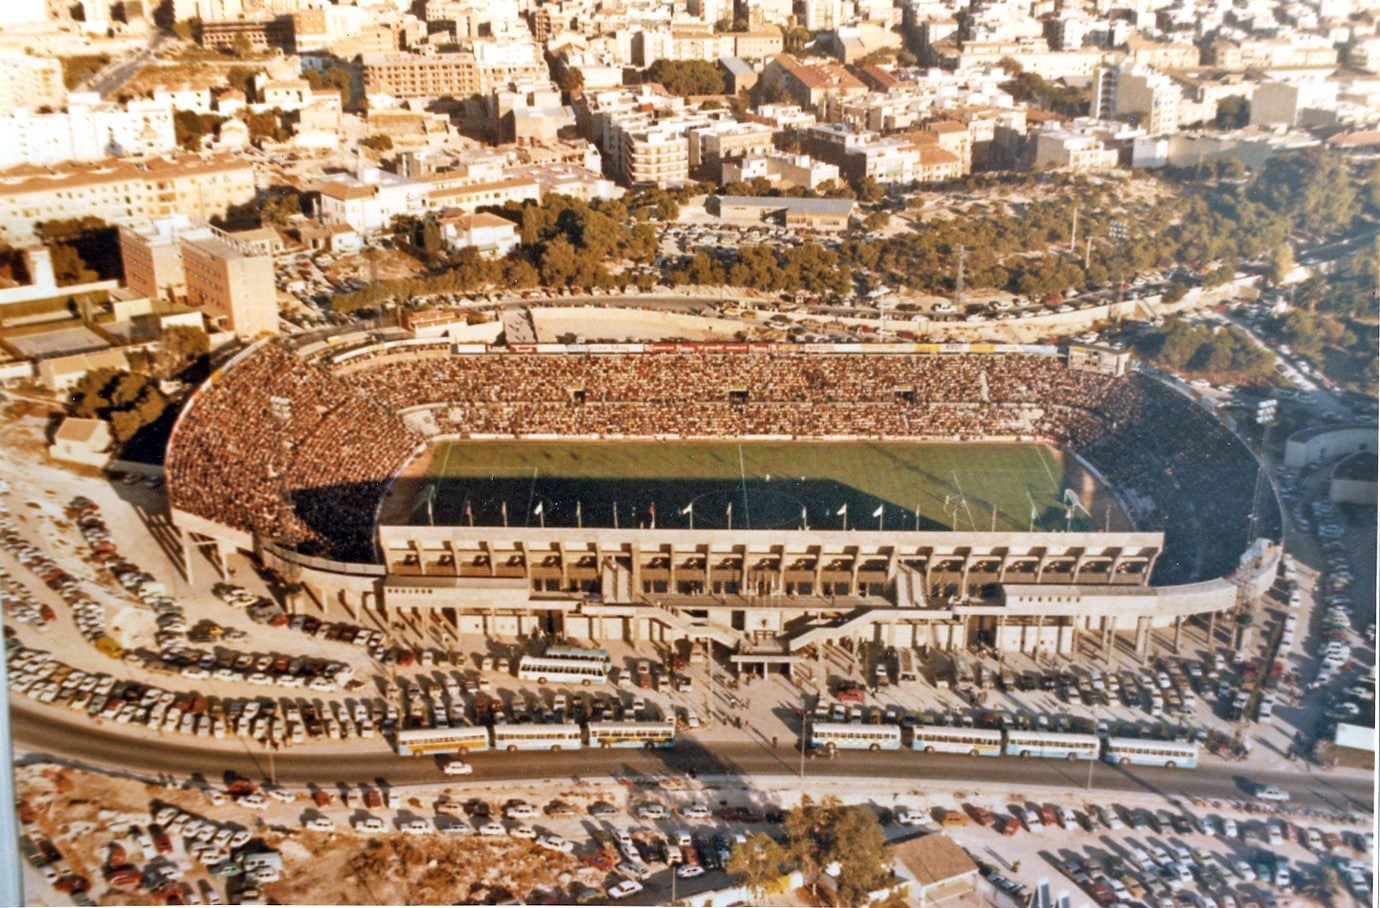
11, 700, 1372, 810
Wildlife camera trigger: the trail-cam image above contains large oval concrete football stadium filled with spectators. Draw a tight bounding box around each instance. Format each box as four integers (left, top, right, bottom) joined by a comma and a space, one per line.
167, 333, 1281, 664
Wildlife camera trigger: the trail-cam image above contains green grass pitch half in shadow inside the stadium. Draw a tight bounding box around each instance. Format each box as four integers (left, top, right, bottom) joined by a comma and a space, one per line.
395, 442, 1127, 530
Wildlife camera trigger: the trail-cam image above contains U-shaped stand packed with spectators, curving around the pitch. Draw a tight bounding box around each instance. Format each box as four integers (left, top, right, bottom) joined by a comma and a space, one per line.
167, 341, 1278, 584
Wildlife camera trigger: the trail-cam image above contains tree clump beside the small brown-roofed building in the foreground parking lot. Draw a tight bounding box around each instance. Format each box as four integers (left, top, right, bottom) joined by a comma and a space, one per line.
726, 795, 891, 905
